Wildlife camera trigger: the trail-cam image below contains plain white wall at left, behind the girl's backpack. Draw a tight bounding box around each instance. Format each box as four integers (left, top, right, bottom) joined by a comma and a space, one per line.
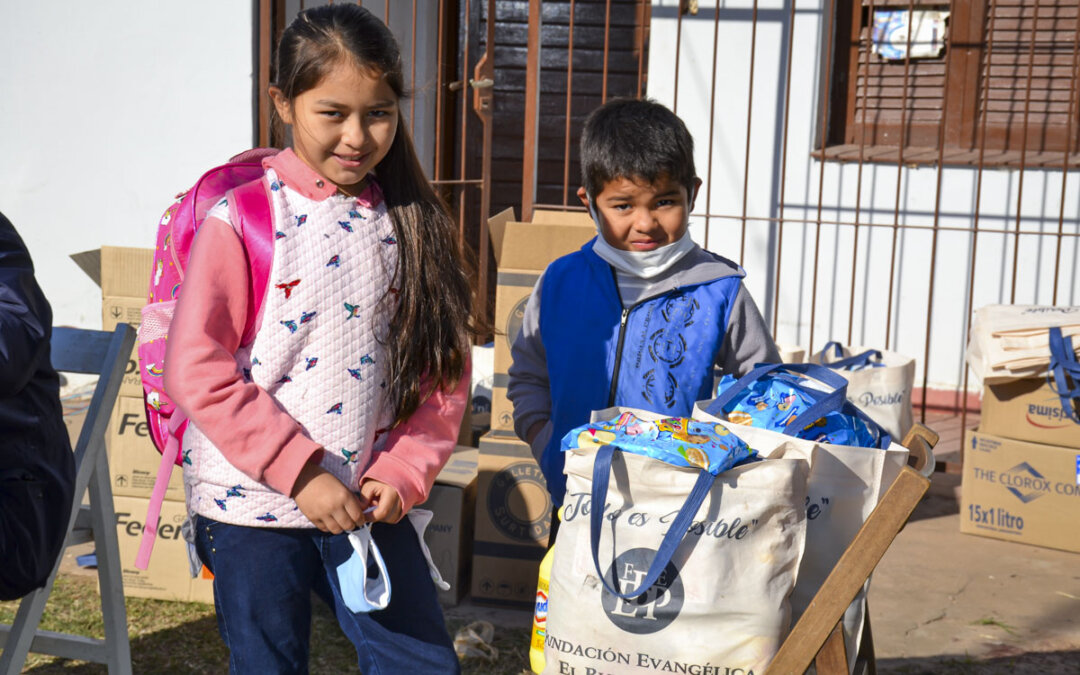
0, 0, 253, 327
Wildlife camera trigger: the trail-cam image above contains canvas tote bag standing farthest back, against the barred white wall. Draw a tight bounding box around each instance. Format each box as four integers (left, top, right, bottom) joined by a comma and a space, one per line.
810, 342, 915, 440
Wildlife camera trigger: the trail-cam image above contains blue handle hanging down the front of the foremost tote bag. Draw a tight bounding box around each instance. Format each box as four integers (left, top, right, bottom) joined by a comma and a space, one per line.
589, 445, 716, 600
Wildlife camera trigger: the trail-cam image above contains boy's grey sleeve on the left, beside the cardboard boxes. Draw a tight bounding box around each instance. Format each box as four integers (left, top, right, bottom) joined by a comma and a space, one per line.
507, 268, 551, 459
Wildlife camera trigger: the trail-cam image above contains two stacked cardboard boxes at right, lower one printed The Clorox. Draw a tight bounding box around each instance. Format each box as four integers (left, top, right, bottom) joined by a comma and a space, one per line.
960, 378, 1080, 552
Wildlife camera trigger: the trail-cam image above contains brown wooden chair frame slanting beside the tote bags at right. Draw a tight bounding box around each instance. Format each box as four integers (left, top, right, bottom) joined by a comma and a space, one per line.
766, 424, 937, 675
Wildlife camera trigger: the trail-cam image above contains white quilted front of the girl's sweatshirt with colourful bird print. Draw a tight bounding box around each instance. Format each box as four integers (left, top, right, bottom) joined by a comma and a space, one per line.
183, 168, 397, 527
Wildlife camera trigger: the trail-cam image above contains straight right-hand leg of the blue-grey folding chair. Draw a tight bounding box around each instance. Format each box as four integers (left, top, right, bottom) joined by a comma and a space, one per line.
90, 453, 132, 675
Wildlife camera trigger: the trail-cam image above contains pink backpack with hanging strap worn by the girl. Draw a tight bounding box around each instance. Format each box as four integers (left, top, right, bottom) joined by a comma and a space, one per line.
135, 148, 278, 569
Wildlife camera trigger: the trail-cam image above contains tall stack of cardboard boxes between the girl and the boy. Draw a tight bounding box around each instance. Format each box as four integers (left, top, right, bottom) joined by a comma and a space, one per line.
472, 210, 596, 607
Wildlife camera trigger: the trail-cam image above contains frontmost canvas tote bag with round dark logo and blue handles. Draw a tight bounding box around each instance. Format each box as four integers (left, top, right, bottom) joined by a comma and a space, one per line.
544, 410, 811, 674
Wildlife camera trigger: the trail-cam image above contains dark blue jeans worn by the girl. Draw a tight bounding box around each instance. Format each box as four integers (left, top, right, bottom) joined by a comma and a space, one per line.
195, 516, 460, 675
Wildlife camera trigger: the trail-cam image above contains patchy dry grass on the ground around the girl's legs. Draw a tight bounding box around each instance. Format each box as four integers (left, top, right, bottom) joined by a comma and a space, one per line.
0, 576, 529, 675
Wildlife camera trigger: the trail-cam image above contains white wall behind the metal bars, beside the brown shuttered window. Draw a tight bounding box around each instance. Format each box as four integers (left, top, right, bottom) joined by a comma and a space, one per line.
648, 0, 1080, 388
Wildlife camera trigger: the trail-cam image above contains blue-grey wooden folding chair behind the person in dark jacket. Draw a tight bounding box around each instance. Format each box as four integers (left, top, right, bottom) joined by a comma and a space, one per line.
0, 323, 135, 675
